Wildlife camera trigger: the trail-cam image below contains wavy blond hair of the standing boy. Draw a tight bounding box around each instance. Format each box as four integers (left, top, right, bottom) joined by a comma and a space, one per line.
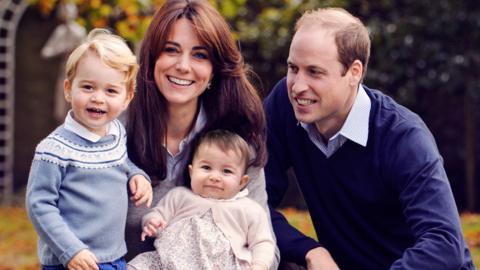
65, 28, 138, 93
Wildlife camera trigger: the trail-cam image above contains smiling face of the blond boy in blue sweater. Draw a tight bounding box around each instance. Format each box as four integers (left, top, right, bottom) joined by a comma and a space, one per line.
64, 52, 133, 136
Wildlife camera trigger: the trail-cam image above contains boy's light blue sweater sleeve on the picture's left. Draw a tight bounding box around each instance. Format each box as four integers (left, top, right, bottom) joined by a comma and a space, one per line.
26, 160, 88, 266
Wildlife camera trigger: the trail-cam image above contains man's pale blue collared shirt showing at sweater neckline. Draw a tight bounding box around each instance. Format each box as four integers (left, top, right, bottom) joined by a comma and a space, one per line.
300, 85, 372, 158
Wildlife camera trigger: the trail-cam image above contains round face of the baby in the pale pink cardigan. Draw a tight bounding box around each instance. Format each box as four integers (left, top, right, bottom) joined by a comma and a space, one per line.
188, 144, 248, 199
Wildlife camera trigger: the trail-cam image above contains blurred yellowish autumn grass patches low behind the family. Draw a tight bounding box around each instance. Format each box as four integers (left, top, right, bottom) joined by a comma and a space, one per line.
0, 207, 480, 270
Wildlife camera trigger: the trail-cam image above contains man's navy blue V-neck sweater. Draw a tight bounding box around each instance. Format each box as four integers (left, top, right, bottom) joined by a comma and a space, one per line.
265, 79, 475, 270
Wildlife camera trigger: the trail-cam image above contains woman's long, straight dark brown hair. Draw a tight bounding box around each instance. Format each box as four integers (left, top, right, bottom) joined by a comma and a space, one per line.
127, 0, 267, 179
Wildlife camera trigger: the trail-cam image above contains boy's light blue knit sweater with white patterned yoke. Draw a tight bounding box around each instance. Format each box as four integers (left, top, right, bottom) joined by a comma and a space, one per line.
26, 120, 148, 266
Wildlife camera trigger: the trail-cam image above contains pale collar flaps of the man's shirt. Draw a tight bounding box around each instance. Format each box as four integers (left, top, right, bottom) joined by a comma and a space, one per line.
299, 85, 372, 146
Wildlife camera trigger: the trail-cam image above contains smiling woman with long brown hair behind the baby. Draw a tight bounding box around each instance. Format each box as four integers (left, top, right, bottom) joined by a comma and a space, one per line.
126, 0, 279, 266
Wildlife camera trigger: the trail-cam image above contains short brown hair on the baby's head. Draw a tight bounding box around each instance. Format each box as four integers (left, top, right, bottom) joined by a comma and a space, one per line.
192, 129, 252, 172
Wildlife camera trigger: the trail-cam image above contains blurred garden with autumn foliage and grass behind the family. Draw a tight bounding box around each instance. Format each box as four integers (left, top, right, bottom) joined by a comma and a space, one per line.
0, 0, 480, 270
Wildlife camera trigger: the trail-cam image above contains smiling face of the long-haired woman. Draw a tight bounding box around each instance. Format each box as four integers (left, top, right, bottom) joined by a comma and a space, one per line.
154, 18, 213, 110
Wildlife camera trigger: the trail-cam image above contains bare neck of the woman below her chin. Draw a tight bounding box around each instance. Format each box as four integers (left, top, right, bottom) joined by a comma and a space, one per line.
164, 102, 198, 155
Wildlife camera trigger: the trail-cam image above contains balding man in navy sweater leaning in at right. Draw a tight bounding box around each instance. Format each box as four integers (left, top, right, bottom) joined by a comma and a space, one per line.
265, 8, 474, 270
